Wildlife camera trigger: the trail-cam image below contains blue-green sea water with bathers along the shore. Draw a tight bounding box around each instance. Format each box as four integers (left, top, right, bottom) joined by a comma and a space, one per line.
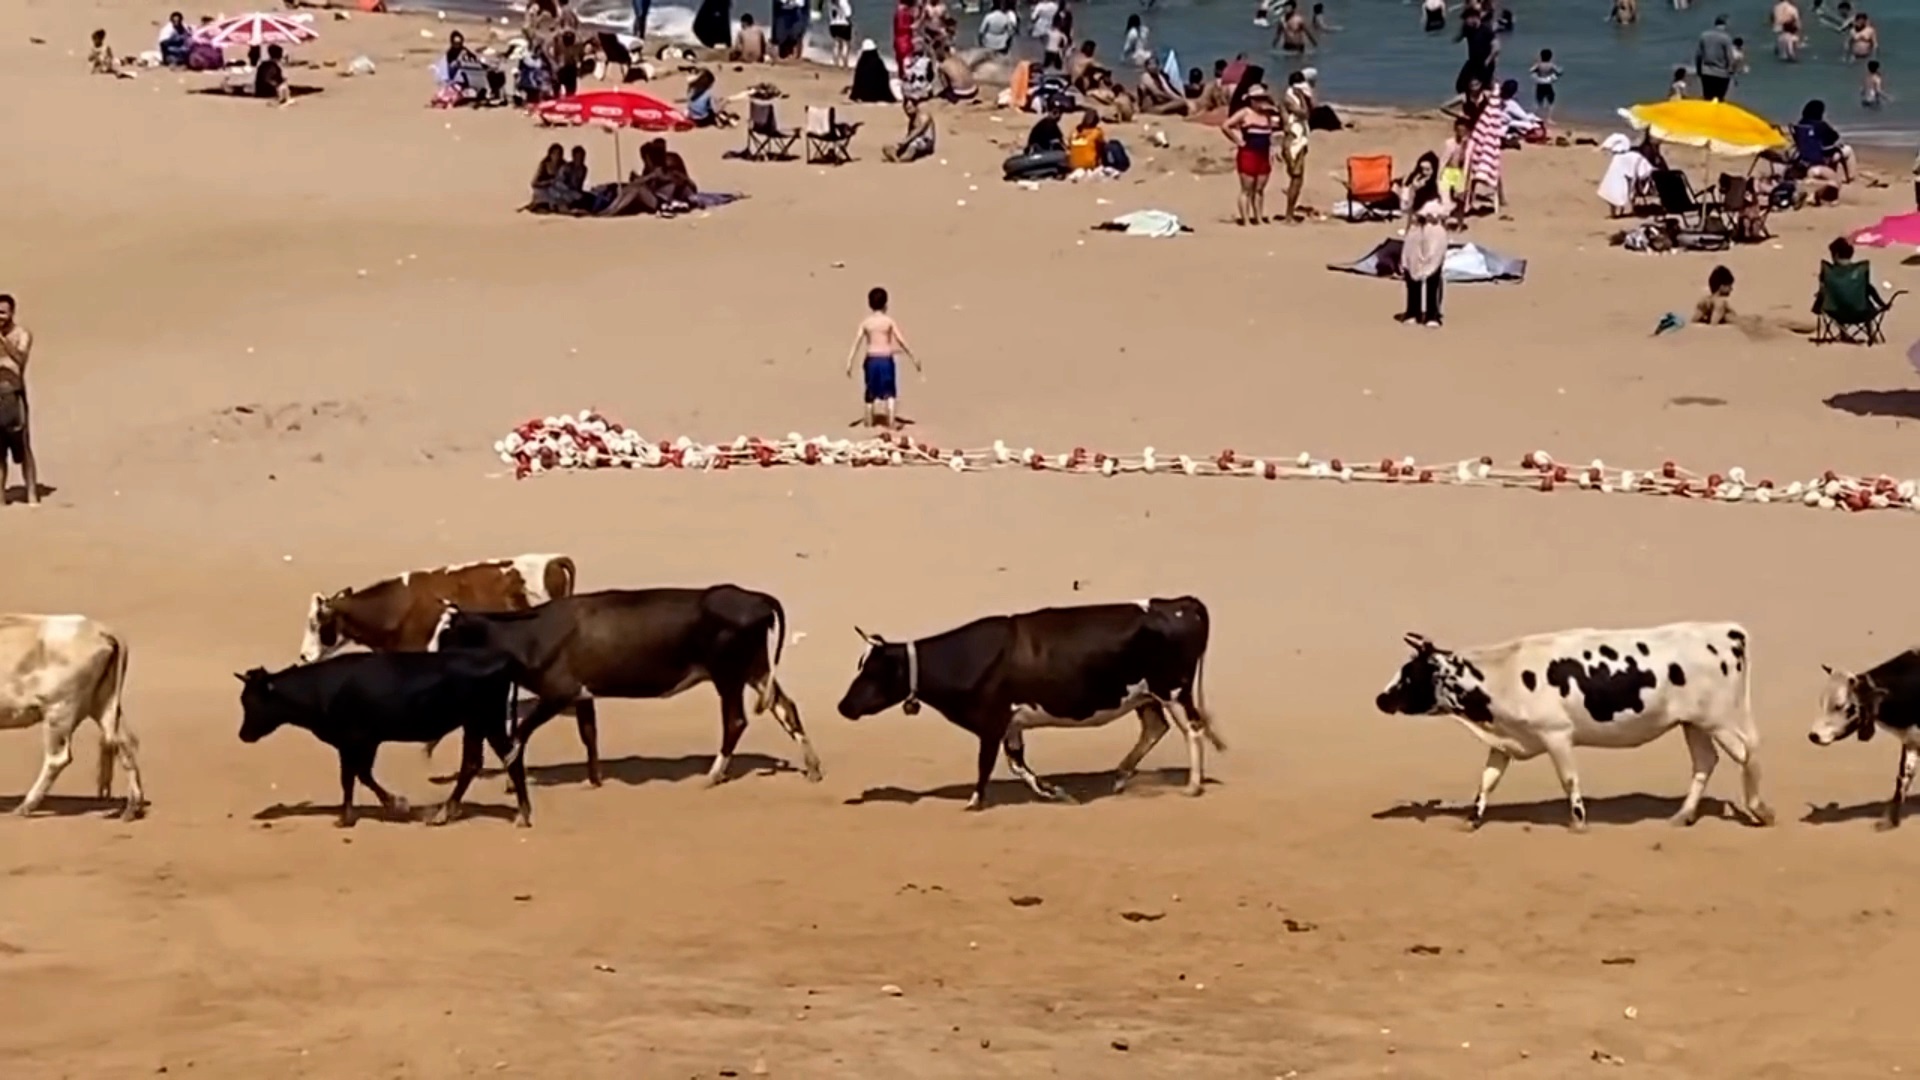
401, 0, 1920, 146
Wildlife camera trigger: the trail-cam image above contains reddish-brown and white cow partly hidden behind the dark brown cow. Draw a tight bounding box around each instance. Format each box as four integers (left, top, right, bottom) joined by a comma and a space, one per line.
300, 555, 576, 663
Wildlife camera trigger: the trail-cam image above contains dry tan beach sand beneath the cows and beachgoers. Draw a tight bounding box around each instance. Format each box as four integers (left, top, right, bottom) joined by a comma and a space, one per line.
0, 0, 1920, 1080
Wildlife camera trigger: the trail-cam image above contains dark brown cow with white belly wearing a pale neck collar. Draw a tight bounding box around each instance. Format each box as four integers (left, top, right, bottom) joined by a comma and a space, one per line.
839, 596, 1227, 811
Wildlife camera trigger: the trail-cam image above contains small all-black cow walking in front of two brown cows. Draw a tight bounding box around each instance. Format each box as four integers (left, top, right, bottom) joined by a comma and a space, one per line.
234, 651, 534, 828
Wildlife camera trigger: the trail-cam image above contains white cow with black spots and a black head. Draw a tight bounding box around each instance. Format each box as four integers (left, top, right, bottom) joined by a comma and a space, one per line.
1375, 623, 1774, 832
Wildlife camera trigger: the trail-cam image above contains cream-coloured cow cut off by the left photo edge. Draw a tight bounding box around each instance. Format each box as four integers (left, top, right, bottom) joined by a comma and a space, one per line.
0, 615, 146, 821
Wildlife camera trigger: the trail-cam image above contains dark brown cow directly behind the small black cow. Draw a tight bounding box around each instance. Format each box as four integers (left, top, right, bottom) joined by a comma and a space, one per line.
432, 584, 820, 788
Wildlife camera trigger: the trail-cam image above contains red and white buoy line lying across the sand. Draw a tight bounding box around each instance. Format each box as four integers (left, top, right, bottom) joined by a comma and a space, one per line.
493, 409, 1920, 511
